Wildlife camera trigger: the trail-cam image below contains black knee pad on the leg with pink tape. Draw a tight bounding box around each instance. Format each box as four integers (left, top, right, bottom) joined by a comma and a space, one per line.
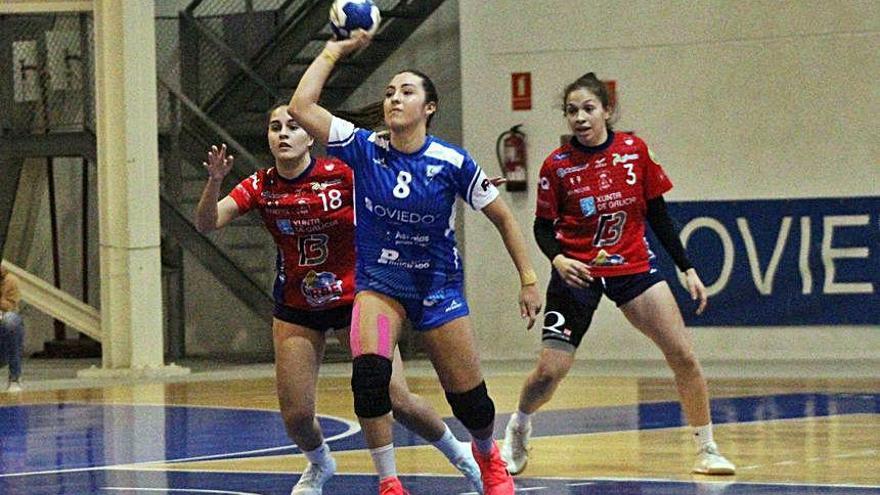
351, 354, 391, 418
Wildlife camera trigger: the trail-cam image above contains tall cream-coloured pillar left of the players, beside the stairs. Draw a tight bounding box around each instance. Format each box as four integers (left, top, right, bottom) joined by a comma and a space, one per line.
80, 0, 188, 376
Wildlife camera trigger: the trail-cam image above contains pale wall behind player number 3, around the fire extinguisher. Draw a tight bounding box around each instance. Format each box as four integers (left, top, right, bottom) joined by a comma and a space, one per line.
460, 0, 880, 360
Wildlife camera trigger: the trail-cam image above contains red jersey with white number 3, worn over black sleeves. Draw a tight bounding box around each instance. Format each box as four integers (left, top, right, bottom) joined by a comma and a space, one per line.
535, 133, 672, 277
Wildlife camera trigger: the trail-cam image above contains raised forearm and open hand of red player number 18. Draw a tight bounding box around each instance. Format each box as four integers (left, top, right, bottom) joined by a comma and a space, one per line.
196, 144, 240, 233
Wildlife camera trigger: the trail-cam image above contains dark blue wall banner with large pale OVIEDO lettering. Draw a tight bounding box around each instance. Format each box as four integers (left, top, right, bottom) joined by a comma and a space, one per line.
649, 197, 880, 326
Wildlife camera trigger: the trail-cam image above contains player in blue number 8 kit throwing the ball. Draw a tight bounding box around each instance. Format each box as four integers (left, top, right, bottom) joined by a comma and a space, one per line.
290, 31, 541, 495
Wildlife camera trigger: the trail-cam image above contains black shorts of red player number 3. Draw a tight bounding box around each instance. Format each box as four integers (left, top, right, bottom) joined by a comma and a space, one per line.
541, 269, 663, 351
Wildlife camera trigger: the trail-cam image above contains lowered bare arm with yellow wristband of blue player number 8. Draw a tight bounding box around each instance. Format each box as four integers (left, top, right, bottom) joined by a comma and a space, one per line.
482, 198, 542, 328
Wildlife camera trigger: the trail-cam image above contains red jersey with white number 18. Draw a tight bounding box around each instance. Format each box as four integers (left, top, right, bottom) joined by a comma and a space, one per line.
229, 158, 355, 311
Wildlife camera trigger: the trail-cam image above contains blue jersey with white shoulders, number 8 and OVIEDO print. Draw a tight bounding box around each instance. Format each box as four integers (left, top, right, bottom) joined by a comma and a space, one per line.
327, 117, 498, 304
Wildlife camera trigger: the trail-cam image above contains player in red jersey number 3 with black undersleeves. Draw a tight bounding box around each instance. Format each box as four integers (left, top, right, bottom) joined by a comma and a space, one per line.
502, 73, 735, 474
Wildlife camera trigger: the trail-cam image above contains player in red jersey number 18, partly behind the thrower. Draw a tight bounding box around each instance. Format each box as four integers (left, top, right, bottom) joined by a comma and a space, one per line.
196, 104, 482, 495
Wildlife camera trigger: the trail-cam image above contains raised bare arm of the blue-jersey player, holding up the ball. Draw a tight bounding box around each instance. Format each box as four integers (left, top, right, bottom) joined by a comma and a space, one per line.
288, 29, 371, 145
